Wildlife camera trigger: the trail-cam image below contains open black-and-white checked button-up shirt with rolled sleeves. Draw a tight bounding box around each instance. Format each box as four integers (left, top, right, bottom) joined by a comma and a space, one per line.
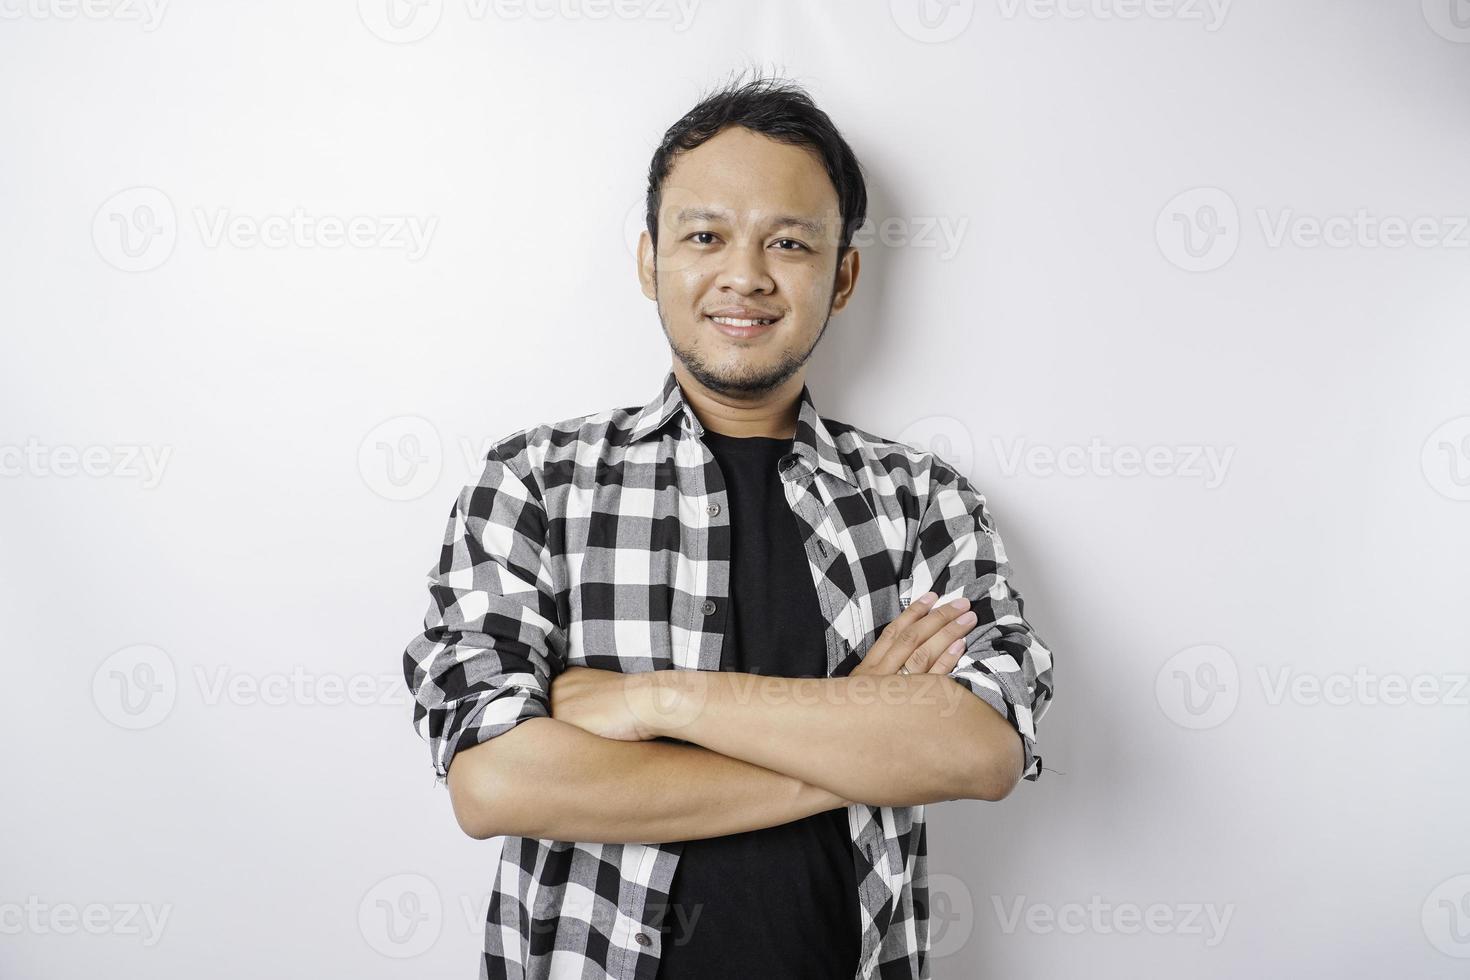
403, 369, 1053, 980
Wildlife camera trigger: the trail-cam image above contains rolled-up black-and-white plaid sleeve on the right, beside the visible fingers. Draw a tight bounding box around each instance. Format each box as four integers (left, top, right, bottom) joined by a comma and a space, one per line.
901, 454, 1053, 782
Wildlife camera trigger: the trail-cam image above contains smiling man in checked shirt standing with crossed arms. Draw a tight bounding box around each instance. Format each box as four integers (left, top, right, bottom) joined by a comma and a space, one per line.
404, 79, 1053, 980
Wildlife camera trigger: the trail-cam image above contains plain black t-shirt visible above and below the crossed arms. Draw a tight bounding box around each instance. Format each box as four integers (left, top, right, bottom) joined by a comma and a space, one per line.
657, 429, 861, 980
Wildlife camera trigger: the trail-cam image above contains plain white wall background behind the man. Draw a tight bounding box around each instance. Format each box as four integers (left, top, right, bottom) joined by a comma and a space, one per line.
0, 0, 1470, 980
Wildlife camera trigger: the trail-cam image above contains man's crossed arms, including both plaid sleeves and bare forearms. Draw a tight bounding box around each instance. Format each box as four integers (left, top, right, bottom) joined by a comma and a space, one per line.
404, 451, 1051, 842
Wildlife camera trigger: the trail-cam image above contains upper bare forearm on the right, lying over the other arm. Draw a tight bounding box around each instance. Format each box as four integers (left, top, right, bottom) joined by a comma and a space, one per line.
648, 670, 1022, 807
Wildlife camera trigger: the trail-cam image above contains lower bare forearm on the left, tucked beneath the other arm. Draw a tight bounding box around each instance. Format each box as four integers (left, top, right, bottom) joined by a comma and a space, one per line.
448, 718, 847, 843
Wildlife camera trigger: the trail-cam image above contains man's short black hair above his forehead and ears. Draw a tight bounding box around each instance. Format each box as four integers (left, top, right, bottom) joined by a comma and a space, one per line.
644, 75, 867, 262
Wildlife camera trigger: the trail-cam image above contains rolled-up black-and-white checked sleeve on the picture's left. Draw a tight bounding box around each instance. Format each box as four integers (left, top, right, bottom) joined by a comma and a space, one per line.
403, 445, 566, 785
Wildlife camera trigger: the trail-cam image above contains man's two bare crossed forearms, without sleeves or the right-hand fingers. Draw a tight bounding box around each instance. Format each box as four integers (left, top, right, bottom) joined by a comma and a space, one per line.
448, 643, 1022, 842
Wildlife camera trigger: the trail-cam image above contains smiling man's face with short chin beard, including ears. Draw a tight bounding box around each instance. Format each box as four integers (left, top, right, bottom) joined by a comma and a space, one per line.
638, 126, 858, 397
